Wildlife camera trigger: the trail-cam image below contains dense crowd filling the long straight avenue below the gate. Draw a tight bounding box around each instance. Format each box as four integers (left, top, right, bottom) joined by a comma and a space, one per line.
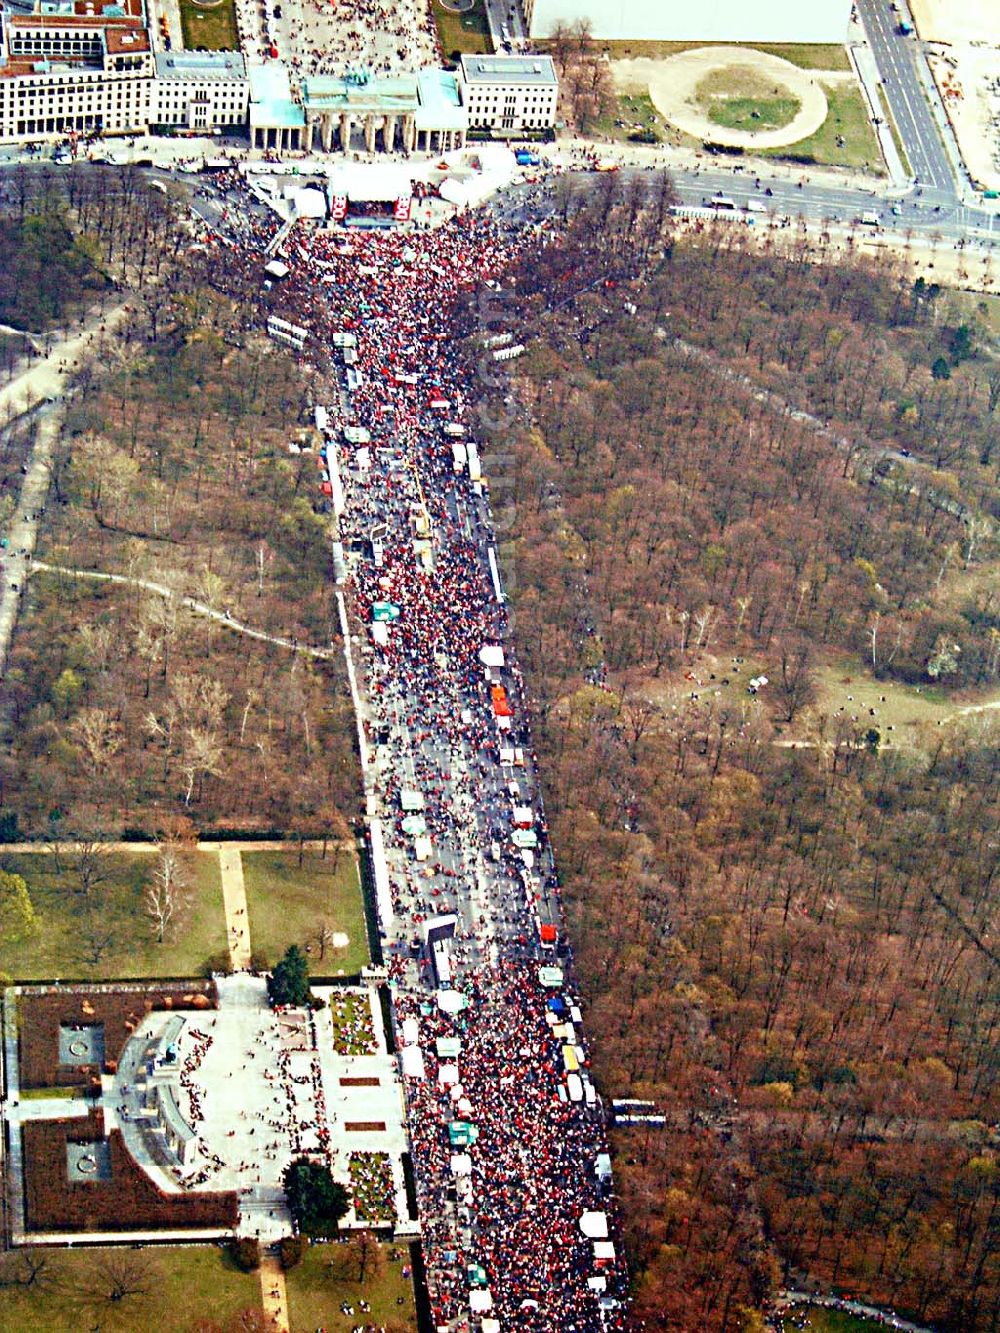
225, 202, 624, 1333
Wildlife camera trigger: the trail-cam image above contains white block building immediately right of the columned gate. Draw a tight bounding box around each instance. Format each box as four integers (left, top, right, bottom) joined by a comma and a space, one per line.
461, 55, 559, 136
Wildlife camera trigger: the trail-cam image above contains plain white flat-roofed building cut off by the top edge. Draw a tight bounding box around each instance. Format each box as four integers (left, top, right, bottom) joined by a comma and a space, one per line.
523, 0, 852, 43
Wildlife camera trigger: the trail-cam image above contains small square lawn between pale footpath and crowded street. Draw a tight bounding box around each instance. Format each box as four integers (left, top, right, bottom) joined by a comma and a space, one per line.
243, 850, 369, 976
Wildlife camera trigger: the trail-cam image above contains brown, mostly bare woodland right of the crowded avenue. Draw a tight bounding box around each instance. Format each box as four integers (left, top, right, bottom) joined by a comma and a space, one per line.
497, 183, 1000, 1333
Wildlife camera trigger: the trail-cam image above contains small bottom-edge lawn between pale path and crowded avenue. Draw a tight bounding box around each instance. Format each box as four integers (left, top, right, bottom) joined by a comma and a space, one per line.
285, 1242, 417, 1333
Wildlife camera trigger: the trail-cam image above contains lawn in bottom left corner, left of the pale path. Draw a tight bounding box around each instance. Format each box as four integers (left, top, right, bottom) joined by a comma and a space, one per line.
0, 1245, 260, 1333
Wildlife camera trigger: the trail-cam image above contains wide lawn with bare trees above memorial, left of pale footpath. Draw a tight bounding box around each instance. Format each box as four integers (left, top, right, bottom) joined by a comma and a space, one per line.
0, 852, 225, 981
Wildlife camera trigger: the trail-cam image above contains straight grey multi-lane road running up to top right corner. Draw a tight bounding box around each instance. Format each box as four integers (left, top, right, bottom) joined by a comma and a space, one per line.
856, 0, 956, 203
